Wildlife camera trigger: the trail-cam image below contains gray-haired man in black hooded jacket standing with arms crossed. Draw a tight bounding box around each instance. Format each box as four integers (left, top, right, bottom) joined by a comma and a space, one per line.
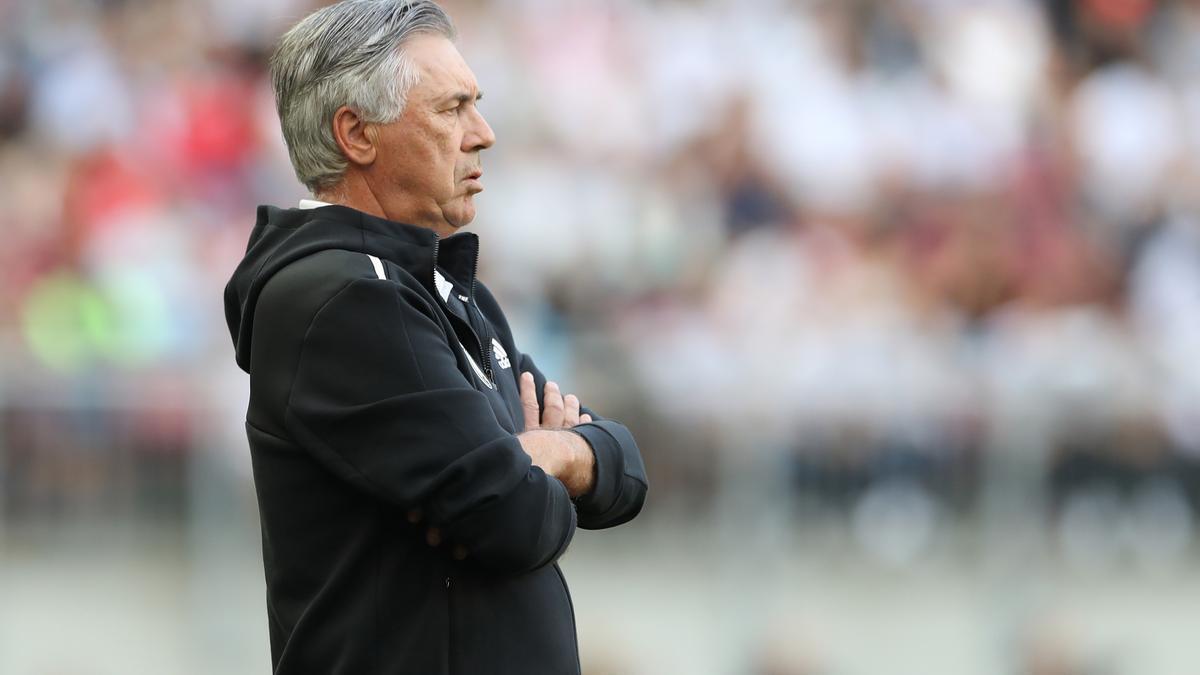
216, 0, 646, 675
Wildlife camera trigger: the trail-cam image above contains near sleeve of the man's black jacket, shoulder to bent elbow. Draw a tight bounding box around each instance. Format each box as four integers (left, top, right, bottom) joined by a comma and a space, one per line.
284, 279, 576, 573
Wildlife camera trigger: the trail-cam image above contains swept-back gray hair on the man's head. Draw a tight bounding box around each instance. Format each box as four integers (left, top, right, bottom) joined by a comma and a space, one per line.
270, 0, 456, 193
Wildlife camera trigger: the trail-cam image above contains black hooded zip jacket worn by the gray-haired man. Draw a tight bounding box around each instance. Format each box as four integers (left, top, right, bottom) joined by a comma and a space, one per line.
217, 205, 646, 675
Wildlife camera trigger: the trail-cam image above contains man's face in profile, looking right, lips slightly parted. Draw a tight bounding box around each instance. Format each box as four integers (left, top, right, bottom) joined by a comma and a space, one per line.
371, 35, 496, 237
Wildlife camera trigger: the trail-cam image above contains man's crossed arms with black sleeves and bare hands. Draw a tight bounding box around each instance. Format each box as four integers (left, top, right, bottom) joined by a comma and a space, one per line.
284, 279, 646, 573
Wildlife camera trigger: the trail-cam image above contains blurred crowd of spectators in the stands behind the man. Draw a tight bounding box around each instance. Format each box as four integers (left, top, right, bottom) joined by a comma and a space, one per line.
0, 0, 1200, 560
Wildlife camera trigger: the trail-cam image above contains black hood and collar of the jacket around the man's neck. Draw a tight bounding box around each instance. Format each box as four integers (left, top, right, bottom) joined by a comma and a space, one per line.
224, 205, 479, 372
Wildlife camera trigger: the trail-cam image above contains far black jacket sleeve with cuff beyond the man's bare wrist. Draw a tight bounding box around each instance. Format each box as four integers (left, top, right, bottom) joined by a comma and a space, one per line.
521, 353, 647, 530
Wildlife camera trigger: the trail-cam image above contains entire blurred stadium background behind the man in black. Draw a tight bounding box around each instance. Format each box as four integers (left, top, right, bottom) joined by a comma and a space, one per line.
0, 0, 1200, 675
